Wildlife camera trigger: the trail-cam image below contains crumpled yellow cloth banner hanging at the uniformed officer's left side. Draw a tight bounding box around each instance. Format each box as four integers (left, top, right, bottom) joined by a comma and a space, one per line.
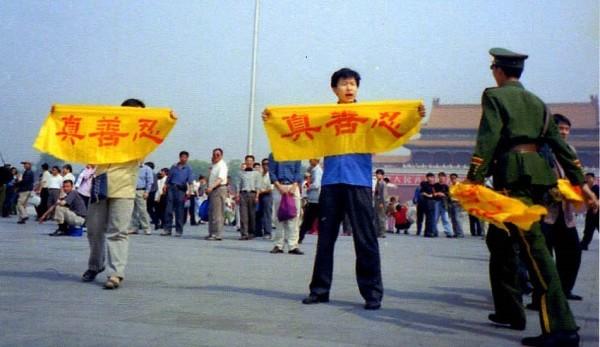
450, 183, 548, 231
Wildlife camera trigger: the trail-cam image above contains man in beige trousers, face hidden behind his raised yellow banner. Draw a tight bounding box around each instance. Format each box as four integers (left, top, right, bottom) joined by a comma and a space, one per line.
34, 99, 176, 289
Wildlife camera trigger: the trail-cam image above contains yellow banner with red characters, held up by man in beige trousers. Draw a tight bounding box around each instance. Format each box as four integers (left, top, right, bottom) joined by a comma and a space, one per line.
33, 105, 177, 164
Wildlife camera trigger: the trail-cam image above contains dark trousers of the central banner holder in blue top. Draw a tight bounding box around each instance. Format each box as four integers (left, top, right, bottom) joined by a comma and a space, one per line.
310, 184, 383, 302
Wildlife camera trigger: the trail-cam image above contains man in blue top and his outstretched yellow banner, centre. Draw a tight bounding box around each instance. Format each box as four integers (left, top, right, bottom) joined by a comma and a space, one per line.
263, 68, 425, 310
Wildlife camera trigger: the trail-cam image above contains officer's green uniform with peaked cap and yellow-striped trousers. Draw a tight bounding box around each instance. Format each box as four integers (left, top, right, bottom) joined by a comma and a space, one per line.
467, 49, 583, 340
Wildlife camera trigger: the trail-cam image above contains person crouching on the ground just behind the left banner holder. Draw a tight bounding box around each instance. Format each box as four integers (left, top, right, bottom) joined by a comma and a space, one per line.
45, 180, 87, 236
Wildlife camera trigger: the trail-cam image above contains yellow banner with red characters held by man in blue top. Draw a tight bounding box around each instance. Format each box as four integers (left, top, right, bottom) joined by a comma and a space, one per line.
264, 100, 423, 160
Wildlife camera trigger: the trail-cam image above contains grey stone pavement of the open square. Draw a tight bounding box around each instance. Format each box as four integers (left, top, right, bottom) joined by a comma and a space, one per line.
0, 217, 598, 347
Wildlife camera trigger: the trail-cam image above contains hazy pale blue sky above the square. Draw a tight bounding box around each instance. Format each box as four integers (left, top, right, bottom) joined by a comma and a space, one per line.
0, 0, 600, 165
